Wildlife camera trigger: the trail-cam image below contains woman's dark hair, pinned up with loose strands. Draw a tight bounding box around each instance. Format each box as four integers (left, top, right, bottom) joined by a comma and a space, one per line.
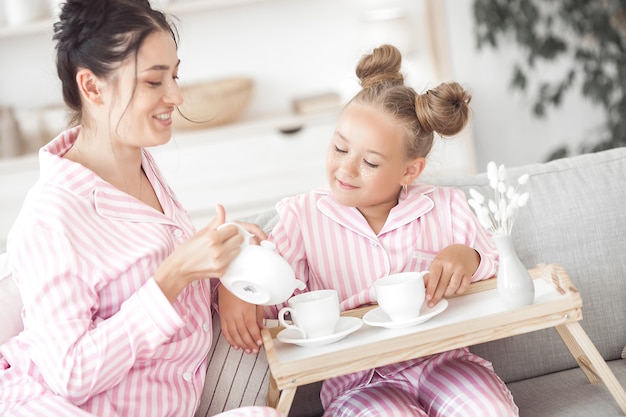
52, 0, 177, 125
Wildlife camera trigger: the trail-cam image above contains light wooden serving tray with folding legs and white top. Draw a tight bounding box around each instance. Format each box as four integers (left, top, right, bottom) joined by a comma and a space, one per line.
262, 264, 626, 415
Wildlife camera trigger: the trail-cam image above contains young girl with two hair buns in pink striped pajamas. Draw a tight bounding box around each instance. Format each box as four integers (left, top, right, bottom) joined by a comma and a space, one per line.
220, 45, 518, 417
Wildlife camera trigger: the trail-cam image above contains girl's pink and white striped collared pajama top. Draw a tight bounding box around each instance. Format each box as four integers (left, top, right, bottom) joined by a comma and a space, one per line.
267, 184, 497, 406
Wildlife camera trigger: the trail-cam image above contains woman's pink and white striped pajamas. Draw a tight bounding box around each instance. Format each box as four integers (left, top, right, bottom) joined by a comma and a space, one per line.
0, 128, 277, 417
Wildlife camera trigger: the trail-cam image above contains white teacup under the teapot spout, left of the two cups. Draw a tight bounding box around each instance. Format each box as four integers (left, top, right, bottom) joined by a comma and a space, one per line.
278, 290, 339, 339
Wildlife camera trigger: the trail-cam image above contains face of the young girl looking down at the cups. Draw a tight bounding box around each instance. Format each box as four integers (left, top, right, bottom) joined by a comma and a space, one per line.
326, 103, 424, 217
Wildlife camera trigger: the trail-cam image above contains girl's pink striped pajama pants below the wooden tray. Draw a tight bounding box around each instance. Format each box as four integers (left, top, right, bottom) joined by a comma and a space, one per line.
321, 348, 518, 417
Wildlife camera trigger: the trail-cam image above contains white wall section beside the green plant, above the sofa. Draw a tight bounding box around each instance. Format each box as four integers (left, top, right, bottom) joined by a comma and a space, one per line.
445, 0, 603, 167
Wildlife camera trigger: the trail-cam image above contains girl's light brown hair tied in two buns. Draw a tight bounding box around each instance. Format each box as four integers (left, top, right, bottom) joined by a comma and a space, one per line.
351, 45, 471, 159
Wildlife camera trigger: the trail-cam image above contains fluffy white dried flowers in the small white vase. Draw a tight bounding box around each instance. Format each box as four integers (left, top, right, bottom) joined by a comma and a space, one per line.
468, 161, 530, 235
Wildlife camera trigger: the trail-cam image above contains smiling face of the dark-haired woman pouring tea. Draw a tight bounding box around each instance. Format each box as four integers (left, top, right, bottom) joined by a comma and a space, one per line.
108, 31, 183, 147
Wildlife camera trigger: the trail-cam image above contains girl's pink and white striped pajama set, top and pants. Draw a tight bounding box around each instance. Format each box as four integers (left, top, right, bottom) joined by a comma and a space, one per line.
267, 184, 517, 417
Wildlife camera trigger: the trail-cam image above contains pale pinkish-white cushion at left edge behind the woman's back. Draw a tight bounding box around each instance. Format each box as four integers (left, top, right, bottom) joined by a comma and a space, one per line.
0, 252, 24, 344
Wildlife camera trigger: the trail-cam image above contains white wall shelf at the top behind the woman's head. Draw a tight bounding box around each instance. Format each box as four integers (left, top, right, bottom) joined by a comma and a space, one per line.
0, 0, 268, 39
